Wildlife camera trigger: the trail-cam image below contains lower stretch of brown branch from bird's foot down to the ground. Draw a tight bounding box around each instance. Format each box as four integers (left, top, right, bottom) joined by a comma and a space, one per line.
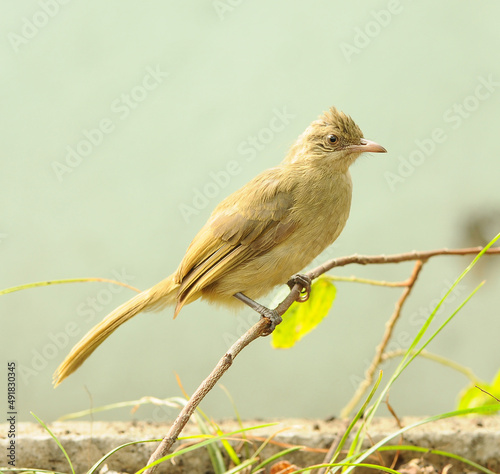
145, 318, 270, 474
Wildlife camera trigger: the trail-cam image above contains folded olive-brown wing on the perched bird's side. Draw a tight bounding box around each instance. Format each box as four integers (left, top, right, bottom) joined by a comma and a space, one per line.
175, 168, 296, 314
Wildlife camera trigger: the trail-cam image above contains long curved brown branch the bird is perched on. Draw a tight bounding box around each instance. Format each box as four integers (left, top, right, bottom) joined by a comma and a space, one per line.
145, 247, 500, 474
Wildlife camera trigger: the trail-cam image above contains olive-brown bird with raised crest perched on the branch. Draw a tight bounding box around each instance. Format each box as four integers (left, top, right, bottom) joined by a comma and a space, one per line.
53, 107, 387, 386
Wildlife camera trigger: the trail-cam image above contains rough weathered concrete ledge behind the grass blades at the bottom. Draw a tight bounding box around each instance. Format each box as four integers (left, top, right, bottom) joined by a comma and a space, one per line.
0, 416, 500, 474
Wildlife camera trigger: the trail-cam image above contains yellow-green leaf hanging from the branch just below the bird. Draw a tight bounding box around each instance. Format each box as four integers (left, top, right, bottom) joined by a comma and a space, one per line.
271, 277, 337, 349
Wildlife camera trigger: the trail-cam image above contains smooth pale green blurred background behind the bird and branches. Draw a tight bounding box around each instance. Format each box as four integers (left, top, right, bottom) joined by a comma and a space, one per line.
0, 0, 500, 421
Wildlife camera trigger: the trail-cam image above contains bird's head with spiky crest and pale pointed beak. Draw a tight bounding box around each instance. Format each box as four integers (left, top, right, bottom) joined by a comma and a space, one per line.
285, 107, 387, 170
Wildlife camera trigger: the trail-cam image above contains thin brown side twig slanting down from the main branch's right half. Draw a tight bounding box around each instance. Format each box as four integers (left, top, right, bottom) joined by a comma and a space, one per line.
340, 260, 423, 418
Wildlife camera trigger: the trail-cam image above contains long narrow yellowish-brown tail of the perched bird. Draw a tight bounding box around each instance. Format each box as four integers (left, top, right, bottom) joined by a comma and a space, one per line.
53, 275, 179, 387
